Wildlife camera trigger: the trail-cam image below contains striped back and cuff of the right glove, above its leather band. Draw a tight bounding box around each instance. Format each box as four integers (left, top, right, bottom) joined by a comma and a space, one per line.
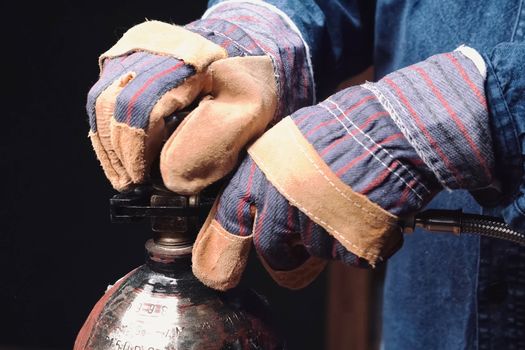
292, 47, 494, 216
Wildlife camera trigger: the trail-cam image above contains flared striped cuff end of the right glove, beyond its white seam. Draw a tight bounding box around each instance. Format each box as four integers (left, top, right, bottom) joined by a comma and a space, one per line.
367, 51, 494, 189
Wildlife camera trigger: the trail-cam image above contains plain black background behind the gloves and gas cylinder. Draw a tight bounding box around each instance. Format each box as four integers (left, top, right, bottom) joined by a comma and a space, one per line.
0, 1, 326, 349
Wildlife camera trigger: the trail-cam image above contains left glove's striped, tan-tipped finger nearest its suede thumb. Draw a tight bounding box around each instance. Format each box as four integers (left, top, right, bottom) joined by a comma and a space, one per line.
111, 57, 202, 183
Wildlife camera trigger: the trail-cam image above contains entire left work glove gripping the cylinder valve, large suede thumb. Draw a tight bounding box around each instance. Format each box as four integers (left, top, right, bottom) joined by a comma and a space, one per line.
87, 3, 313, 194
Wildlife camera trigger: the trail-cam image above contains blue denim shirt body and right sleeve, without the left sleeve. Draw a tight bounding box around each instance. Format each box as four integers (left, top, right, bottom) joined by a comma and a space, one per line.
375, 0, 525, 349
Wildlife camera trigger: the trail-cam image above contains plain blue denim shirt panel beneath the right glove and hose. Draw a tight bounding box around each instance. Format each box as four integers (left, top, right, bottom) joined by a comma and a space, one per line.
382, 191, 480, 349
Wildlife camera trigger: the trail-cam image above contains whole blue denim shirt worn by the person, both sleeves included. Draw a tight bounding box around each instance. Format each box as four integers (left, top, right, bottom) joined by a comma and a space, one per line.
210, 0, 525, 349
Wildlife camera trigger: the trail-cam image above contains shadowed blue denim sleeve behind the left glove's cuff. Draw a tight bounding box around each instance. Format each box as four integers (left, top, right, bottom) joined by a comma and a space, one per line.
208, 0, 375, 97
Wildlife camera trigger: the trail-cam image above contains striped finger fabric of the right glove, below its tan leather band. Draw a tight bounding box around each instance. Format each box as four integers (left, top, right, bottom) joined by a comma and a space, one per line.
215, 156, 369, 271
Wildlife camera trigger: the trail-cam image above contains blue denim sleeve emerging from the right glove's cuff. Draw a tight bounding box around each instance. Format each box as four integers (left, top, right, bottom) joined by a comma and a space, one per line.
484, 43, 525, 231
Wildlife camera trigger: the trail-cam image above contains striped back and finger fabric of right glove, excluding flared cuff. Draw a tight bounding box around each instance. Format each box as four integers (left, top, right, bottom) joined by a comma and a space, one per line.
211, 87, 432, 270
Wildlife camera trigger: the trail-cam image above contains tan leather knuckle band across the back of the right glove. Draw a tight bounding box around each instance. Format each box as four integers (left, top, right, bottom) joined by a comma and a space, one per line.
248, 117, 402, 265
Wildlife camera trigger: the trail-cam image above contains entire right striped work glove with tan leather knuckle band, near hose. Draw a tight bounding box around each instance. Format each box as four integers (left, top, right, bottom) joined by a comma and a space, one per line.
193, 47, 494, 290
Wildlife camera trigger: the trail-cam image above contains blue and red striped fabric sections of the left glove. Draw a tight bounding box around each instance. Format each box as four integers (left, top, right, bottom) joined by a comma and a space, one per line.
86, 3, 314, 136
